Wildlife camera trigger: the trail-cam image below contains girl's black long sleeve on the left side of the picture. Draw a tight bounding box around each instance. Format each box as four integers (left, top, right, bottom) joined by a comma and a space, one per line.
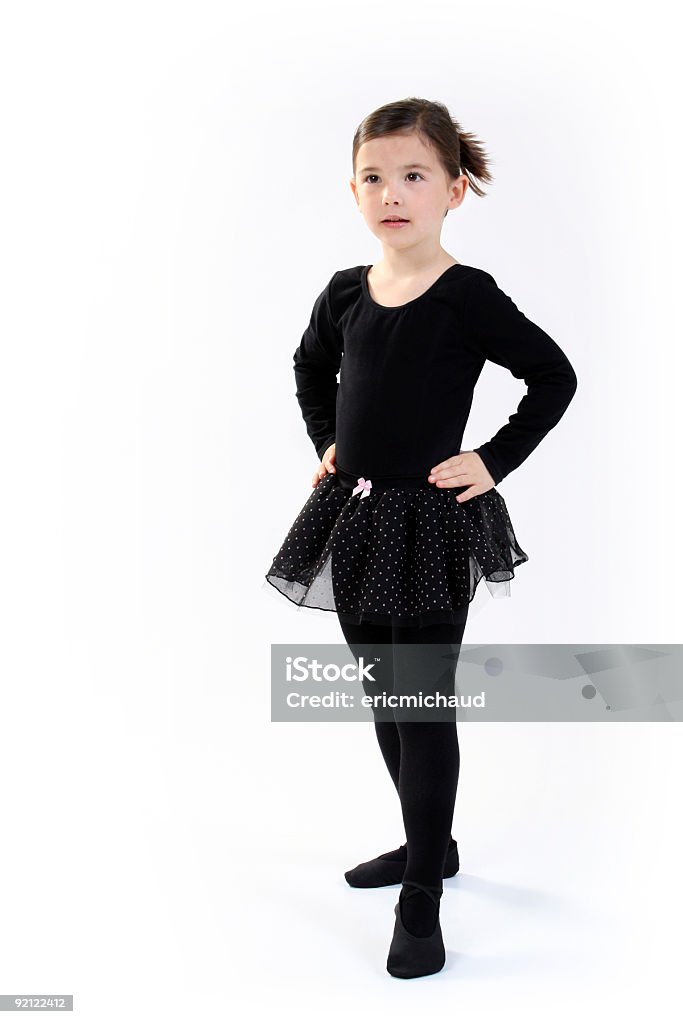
294, 271, 343, 459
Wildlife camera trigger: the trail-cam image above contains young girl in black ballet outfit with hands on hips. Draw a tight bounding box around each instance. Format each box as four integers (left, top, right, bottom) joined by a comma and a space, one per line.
266, 98, 577, 978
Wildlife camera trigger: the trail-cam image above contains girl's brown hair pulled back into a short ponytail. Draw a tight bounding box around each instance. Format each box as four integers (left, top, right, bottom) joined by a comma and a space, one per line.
351, 96, 494, 196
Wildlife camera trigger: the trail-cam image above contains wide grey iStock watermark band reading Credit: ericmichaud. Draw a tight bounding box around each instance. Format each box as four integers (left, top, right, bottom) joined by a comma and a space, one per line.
270, 643, 683, 722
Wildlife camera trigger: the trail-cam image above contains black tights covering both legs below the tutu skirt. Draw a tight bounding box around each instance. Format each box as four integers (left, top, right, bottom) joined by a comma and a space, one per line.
339, 608, 468, 886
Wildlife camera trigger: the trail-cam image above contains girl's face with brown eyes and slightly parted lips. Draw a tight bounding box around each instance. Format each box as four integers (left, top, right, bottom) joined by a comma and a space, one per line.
350, 133, 468, 249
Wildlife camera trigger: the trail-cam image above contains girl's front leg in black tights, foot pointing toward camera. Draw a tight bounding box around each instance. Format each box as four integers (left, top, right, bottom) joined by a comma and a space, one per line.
393, 608, 467, 936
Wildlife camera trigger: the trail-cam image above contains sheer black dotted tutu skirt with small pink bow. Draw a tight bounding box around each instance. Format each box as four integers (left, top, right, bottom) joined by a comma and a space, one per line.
265, 465, 528, 627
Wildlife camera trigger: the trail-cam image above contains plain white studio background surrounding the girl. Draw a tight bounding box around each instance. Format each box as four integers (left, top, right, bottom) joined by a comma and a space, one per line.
0, 0, 683, 1024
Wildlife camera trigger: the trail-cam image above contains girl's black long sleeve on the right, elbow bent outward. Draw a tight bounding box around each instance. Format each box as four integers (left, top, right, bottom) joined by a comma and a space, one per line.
464, 271, 578, 484
